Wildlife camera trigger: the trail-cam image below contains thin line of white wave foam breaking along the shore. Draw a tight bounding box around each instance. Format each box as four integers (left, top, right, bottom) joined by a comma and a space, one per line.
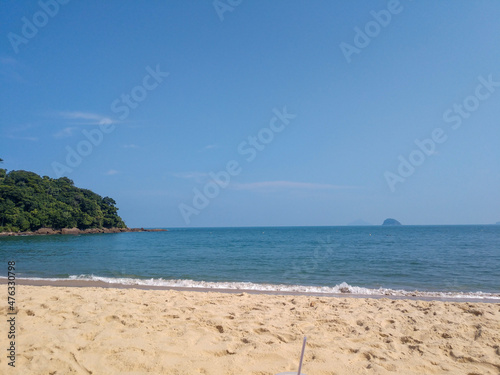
0, 275, 500, 301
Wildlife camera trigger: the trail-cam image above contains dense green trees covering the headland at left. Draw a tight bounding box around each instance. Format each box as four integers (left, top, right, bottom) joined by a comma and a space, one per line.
0, 167, 126, 232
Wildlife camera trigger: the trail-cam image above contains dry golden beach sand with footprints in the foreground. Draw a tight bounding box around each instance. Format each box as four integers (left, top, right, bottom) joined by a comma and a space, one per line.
0, 285, 500, 375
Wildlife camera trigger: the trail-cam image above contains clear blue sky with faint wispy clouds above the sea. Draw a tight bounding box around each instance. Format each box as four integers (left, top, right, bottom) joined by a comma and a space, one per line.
0, 0, 500, 228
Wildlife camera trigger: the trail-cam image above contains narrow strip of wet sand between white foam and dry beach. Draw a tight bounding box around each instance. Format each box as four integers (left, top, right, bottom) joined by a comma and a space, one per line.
0, 278, 500, 304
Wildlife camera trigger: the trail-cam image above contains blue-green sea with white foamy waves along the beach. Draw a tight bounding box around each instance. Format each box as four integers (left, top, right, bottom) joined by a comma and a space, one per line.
0, 225, 500, 302
